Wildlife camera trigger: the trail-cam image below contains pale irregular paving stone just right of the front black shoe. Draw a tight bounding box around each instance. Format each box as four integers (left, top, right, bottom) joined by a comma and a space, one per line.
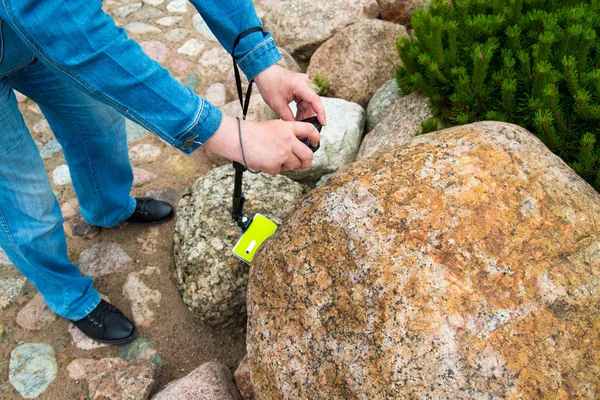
123, 268, 162, 327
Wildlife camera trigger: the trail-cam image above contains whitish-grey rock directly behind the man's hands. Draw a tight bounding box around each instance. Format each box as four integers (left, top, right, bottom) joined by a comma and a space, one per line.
284, 97, 365, 180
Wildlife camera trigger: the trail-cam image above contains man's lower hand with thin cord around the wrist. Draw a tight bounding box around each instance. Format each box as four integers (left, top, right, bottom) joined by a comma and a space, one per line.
203, 114, 321, 175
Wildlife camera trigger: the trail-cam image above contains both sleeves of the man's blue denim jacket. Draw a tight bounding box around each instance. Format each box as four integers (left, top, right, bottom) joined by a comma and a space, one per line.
0, 0, 278, 154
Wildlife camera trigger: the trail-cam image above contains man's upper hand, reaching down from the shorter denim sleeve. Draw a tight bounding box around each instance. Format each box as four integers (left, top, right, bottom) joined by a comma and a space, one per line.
254, 65, 327, 126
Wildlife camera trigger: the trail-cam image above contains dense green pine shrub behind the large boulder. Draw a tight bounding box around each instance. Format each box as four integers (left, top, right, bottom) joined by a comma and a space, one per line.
396, 0, 600, 190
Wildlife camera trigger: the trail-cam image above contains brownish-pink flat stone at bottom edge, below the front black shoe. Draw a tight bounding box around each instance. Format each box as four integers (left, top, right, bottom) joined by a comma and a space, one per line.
67, 358, 156, 400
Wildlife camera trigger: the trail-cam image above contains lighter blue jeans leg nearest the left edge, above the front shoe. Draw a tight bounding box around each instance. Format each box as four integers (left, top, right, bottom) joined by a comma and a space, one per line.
0, 78, 100, 320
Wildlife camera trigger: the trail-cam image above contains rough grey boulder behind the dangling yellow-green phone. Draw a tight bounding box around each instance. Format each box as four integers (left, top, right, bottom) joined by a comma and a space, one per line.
173, 166, 304, 326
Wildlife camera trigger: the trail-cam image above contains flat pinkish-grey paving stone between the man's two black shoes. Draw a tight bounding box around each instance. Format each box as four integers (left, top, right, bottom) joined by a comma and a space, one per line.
79, 242, 131, 278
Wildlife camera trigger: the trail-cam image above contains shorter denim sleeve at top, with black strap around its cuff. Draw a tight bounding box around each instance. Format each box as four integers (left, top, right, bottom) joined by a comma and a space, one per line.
190, 0, 281, 79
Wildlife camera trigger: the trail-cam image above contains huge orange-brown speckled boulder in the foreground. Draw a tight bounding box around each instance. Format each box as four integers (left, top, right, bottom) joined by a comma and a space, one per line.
248, 122, 600, 399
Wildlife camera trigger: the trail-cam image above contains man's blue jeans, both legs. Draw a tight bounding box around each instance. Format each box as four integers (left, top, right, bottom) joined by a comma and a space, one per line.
0, 24, 136, 320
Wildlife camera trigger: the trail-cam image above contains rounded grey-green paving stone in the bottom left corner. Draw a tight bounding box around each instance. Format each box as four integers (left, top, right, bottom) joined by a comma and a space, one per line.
8, 343, 57, 399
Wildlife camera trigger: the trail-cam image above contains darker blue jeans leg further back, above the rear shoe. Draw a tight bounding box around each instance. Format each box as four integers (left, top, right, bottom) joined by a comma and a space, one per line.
8, 63, 136, 227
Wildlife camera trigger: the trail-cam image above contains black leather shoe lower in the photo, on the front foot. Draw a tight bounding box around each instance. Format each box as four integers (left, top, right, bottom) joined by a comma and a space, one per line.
71, 300, 137, 344
